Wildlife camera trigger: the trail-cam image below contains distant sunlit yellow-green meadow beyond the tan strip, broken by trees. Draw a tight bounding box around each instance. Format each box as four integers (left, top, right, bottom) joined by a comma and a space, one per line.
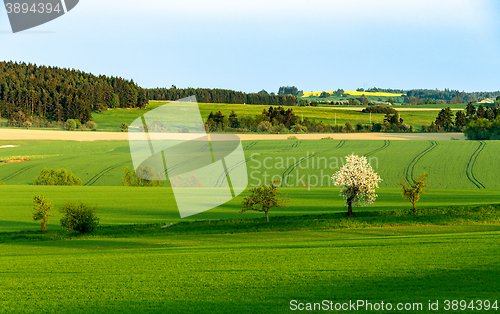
93, 102, 446, 131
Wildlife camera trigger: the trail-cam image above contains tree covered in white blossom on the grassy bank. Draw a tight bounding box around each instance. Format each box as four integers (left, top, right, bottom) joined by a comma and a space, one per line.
332, 154, 382, 217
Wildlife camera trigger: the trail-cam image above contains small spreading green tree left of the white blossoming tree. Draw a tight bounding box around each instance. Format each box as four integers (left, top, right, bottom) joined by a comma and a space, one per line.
240, 182, 289, 222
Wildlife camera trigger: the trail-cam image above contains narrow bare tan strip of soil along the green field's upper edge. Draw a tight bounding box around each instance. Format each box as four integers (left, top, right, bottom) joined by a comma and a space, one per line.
0, 129, 465, 144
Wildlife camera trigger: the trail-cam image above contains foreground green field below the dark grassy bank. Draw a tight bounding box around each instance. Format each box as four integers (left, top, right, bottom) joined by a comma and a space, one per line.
0, 225, 500, 313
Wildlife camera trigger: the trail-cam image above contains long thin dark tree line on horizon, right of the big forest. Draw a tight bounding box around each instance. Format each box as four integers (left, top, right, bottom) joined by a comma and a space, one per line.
146, 87, 297, 106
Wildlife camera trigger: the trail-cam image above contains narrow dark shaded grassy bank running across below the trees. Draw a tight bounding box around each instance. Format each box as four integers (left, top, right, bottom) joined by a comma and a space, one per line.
0, 205, 500, 243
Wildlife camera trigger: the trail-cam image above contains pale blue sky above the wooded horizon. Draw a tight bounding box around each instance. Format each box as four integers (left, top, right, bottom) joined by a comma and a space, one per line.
0, 0, 500, 92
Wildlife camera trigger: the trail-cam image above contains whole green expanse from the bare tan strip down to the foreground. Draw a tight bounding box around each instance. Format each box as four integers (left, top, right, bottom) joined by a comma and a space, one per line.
0, 139, 500, 313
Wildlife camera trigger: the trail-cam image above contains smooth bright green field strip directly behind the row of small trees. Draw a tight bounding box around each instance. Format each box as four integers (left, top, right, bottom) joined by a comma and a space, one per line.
0, 185, 500, 232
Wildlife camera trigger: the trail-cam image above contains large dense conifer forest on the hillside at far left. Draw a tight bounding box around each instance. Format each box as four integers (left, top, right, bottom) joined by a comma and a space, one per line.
0, 62, 148, 126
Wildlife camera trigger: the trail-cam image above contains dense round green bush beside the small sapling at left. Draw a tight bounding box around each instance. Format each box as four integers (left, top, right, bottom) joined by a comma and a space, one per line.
59, 202, 99, 233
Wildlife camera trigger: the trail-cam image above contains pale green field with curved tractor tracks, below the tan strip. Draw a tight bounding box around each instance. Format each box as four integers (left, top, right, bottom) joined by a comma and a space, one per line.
0, 140, 500, 189
